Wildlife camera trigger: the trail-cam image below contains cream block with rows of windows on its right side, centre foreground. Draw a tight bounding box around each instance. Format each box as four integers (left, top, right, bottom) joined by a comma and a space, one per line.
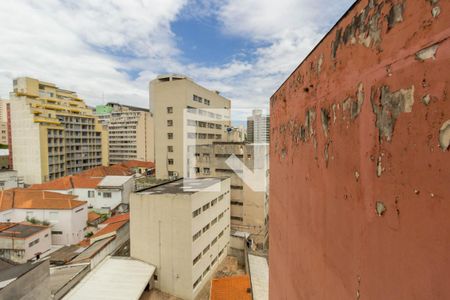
130, 178, 230, 299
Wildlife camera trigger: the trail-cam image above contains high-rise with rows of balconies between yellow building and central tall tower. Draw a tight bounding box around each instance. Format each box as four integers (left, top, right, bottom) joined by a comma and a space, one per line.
95, 103, 155, 164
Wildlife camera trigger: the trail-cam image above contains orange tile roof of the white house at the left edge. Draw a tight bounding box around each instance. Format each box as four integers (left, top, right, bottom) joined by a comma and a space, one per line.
0, 189, 87, 211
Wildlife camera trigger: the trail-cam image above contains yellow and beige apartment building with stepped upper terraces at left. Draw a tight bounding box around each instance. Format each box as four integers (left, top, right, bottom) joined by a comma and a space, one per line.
10, 77, 108, 184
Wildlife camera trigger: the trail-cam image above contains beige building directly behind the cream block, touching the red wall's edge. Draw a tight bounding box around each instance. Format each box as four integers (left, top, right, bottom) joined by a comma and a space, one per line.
191, 142, 269, 247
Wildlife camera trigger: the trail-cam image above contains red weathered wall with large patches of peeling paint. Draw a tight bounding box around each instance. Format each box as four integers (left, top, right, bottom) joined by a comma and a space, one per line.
269, 0, 450, 300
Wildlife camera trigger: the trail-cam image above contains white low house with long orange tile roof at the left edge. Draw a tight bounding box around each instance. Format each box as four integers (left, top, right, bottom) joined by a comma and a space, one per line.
0, 189, 88, 245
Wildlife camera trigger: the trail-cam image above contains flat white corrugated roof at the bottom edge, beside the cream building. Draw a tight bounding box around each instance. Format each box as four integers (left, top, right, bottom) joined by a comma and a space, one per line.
64, 257, 155, 300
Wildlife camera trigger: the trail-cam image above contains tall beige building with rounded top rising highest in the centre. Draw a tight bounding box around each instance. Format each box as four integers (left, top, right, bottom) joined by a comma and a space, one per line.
150, 74, 231, 178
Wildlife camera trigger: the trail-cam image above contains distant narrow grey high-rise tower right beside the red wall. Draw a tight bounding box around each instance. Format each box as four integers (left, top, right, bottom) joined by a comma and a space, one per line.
247, 109, 270, 143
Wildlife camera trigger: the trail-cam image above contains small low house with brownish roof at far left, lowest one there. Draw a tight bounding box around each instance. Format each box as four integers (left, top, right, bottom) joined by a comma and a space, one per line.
0, 223, 51, 263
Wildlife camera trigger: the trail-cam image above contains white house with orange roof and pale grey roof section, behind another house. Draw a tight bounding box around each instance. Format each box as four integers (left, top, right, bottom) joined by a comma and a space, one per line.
30, 175, 134, 213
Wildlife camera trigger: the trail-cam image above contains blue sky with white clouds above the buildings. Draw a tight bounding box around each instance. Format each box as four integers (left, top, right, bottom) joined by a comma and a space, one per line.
0, 0, 353, 118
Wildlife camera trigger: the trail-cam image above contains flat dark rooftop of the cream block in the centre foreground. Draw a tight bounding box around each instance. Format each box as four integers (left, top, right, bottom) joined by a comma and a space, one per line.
138, 177, 224, 194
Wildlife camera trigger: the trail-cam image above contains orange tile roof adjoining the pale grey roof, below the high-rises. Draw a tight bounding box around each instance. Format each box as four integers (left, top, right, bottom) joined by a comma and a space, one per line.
30, 175, 102, 190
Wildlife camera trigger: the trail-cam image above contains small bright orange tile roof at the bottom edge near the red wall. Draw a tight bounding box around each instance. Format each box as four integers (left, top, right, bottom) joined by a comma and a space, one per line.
209, 275, 252, 300
